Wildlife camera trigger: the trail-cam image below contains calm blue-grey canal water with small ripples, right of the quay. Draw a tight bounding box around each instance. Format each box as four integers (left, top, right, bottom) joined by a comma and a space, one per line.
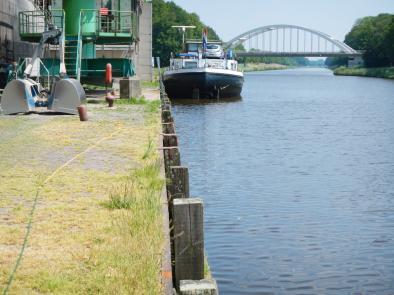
173, 69, 394, 294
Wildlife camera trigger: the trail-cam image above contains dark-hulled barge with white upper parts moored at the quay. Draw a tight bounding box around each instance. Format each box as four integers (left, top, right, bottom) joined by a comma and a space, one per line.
163, 40, 244, 99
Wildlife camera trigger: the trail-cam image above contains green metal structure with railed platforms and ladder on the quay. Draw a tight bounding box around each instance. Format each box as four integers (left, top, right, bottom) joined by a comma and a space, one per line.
19, 0, 141, 84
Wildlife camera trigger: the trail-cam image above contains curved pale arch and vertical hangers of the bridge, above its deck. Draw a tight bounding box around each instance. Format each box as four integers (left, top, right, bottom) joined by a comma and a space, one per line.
226, 24, 360, 56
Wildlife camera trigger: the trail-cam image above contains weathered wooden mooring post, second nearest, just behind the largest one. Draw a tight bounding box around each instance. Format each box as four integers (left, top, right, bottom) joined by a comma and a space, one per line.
167, 166, 190, 200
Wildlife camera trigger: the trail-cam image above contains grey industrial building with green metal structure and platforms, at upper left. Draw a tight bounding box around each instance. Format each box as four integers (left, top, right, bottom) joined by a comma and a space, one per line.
0, 0, 152, 88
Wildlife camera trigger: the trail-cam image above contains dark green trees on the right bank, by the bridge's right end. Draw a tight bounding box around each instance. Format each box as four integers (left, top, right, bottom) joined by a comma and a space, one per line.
326, 13, 394, 67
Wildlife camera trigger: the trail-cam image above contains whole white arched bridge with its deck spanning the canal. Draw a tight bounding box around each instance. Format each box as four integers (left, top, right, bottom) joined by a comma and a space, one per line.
225, 24, 362, 57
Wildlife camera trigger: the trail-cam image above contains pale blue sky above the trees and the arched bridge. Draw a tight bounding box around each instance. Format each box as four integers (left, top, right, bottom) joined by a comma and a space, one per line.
169, 0, 394, 41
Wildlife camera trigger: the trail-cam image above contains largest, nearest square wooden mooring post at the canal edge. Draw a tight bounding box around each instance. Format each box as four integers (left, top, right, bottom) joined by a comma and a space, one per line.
172, 198, 204, 288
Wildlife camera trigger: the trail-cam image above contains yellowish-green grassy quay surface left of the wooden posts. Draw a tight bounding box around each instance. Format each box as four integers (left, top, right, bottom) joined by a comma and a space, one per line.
0, 96, 164, 294
